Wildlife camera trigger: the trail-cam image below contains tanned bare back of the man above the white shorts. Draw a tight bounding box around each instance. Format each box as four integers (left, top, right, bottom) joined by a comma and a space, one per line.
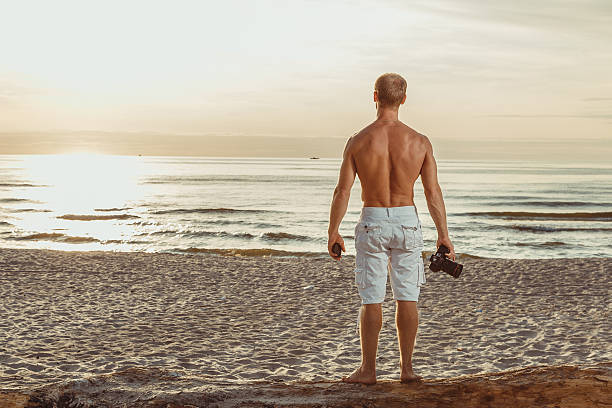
349, 121, 428, 207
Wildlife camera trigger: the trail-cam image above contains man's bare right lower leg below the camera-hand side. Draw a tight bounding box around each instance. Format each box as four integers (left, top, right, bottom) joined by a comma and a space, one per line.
395, 300, 421, 382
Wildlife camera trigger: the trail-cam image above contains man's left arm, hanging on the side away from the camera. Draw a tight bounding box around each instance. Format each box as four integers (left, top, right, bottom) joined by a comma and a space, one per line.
327, 137, 357, 259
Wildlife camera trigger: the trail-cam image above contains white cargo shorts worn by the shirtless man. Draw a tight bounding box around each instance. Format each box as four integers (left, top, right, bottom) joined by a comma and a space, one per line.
355, 206, 426, 304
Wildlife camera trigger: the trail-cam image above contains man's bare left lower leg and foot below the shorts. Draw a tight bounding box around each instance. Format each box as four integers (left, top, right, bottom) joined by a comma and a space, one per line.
342, 303, 382, 384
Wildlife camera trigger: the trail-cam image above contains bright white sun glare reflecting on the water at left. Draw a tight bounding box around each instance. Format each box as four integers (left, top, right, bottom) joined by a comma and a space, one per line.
13, 153, 147, 249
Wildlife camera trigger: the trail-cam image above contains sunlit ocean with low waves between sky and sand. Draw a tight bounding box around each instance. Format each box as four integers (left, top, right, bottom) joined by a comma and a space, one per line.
0, 154, 612, 258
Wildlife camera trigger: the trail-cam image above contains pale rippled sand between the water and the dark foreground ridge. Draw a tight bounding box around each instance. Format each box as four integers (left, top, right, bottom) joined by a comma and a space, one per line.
0, 249, 612, 401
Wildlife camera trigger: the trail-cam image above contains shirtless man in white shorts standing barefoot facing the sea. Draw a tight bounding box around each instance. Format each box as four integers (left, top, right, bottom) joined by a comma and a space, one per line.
327, 74, 455, 384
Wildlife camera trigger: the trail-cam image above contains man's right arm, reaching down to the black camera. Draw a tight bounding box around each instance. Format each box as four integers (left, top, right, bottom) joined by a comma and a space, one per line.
421, 137, 455, 261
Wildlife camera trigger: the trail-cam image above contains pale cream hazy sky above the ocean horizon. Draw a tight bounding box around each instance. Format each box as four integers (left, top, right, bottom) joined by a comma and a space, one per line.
0, 0, 612, 161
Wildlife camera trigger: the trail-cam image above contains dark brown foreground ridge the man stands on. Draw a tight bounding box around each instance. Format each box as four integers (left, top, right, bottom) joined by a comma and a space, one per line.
0, 362, 612, 408
